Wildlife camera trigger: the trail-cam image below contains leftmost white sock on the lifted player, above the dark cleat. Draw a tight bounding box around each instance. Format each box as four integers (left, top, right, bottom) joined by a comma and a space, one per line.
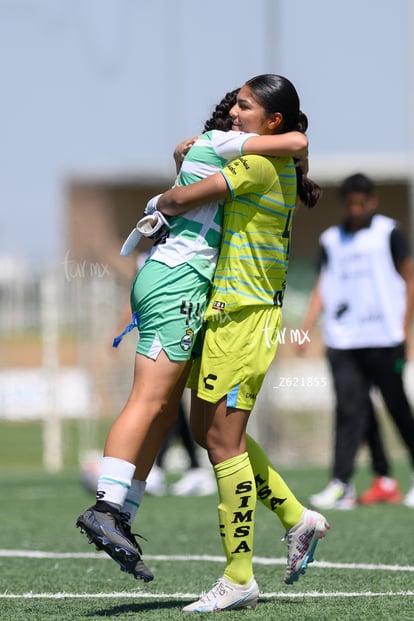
96, 457, 135, 509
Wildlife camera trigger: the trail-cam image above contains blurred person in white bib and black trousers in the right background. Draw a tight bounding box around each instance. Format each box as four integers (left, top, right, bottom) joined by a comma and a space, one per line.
302, 174, 414, 509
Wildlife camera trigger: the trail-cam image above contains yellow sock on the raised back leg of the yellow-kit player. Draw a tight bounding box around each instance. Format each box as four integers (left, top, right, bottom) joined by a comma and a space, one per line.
246, 435, 304, 530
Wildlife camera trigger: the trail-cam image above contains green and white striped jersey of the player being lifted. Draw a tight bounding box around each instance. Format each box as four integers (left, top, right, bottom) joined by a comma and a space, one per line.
150, 130, 256, 280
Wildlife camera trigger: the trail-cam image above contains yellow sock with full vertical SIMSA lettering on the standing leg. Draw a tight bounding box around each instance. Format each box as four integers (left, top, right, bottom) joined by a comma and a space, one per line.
214, 453, 256, 584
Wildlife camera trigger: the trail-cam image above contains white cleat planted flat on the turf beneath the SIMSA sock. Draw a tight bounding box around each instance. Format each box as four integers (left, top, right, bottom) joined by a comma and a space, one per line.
183, 576, 259, 612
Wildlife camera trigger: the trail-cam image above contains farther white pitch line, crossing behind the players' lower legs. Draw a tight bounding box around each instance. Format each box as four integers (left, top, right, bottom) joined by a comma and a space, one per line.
0, 550, 414, 572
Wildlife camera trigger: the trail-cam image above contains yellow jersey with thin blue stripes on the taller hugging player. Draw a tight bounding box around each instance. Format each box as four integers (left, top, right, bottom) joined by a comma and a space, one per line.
207, 155, 296, 317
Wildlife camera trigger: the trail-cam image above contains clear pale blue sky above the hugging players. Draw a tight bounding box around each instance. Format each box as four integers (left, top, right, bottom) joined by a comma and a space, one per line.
0, 0, 414, 267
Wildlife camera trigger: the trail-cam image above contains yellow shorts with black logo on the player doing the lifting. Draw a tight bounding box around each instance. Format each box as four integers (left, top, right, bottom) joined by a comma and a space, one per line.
187, 306, 282, 411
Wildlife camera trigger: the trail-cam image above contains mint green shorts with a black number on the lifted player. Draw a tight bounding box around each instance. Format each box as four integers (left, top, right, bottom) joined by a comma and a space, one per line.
131, 260, 210, 361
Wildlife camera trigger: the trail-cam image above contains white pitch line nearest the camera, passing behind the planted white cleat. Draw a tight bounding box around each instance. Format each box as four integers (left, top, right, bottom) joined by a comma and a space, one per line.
0, 591, 414, 599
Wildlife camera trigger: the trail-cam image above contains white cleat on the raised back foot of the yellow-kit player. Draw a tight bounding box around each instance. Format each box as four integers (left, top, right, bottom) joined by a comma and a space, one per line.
284, 509, 331, 584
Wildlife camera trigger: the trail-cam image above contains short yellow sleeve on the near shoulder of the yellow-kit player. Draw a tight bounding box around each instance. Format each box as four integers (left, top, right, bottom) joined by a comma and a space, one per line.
220, 155, 276, 198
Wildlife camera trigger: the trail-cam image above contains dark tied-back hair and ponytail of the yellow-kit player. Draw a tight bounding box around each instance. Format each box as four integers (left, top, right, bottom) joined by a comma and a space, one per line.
246, 73, 322, 208
